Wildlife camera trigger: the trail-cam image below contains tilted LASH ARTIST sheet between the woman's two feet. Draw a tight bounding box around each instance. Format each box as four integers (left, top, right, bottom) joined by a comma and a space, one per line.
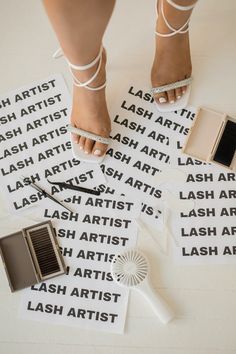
101, 79, 194, 229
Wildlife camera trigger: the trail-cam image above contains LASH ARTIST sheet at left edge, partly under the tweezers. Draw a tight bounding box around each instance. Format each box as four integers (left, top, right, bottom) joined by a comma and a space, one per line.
0, 75, 105, 211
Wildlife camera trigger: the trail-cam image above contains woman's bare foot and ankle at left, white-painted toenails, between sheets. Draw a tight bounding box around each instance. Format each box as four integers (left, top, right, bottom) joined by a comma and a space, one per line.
71, 50, 111, 156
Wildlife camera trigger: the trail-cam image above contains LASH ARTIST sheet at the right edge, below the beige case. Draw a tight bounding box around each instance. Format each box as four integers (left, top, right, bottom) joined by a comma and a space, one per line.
166, 109, 236, 264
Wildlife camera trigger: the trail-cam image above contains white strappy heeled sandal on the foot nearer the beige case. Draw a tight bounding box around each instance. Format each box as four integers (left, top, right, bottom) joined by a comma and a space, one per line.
151, 0, 198, 112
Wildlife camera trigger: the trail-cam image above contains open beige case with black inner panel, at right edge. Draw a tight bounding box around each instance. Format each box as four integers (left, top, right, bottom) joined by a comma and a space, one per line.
182, 107, 236, 171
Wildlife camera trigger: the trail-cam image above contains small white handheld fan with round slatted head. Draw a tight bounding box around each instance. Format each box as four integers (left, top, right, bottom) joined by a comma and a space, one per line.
111, 249, 174, 323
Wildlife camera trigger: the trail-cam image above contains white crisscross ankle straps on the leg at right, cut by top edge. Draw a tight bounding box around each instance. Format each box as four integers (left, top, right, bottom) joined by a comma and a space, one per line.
155, 0, 198, 37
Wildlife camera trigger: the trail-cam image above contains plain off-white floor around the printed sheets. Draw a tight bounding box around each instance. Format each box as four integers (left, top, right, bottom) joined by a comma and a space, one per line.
0, 0, 236, 354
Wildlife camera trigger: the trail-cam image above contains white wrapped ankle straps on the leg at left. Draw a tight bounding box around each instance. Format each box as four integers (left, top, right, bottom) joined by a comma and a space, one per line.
53, 46, 106, 91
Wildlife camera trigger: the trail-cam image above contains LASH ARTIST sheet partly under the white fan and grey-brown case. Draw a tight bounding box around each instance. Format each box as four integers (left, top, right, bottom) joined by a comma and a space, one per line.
20, 193, 140, 333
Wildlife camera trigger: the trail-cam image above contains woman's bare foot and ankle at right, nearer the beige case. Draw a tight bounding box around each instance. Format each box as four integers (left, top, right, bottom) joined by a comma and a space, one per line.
151, 0, 192, 103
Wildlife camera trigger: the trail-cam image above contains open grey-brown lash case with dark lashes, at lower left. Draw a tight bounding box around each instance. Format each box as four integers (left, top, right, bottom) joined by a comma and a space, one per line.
0, 221, 66, 292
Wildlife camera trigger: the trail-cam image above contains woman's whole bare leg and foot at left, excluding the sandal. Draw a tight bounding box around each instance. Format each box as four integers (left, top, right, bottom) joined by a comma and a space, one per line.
43, 0, 115, 155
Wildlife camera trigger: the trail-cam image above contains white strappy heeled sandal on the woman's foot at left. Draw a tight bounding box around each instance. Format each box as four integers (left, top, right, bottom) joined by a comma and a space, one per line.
53, 46, 110, 163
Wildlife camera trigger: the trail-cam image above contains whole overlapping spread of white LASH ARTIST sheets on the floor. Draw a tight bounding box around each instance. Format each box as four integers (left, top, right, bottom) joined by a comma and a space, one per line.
0, 76, 236, 332
